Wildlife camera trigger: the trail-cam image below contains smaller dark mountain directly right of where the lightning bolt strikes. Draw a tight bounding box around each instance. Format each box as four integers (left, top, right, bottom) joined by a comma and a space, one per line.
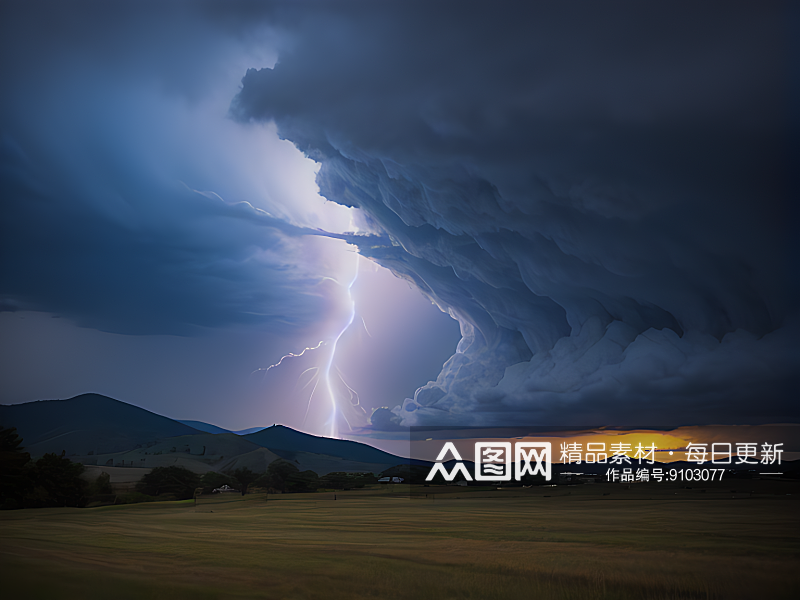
243, 425, 416, 466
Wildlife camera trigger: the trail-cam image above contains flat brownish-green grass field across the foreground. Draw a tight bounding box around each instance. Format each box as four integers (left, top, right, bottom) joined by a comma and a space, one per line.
0, 481, 800, 600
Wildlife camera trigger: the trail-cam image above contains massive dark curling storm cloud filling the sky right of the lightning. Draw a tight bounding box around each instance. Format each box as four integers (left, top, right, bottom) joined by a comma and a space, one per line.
231, 2, 798, 425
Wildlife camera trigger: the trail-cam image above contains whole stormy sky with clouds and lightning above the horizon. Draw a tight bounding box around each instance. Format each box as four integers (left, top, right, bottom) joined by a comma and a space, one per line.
0, 2, 800, 435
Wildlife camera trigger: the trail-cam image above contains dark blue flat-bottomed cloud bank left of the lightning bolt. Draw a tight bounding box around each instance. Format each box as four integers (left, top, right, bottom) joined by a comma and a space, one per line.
0, 138, 332, 334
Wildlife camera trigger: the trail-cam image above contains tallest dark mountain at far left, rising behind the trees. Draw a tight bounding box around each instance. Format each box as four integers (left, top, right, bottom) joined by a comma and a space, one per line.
0, 394, 200, 457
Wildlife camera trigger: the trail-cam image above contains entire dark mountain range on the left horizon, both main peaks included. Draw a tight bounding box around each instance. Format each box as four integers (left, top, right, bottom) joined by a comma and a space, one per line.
0, 394, 418, 475
